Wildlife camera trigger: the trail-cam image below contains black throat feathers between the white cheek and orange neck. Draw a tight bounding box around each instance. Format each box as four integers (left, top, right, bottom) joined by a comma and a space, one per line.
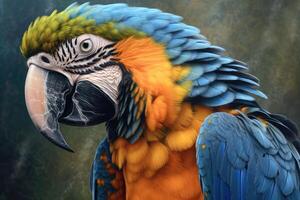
106, 65, 146, 143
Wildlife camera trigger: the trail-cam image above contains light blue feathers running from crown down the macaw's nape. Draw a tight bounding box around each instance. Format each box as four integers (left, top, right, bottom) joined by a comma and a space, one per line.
64, 4, 266, 106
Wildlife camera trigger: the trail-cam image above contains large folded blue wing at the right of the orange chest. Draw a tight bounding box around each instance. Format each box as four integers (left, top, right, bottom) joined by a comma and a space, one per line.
196, 113, 300, 199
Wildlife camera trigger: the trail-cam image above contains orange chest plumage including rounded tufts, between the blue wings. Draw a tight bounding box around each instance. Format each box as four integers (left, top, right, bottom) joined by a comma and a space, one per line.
111, 104, 211, 200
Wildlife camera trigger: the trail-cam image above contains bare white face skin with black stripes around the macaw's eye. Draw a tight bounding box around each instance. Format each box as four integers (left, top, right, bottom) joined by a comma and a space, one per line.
28, 34, 122, 104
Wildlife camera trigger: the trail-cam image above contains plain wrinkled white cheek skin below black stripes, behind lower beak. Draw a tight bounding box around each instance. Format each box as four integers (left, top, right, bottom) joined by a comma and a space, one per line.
78, 65, 122, 104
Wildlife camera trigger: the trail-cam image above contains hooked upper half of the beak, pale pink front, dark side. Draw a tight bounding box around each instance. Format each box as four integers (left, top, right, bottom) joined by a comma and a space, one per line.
25, 65, 73, 152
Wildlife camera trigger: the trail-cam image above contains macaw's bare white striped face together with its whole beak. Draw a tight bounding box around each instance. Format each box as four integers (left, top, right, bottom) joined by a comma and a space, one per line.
25, 34, 122, 150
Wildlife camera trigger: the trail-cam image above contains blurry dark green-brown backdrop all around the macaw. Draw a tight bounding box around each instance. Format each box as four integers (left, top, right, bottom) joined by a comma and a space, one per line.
0, 0, 300, 200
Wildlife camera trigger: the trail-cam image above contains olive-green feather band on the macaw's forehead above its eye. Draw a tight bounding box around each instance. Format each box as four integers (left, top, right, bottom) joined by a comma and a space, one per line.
20, 7, 145, 58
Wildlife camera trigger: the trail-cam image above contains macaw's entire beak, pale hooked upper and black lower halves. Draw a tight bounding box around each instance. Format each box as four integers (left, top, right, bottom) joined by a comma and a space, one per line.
25, 54, 116, 152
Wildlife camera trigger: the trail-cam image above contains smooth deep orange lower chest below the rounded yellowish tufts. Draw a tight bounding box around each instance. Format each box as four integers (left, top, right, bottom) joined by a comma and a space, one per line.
123, 148, 203, 200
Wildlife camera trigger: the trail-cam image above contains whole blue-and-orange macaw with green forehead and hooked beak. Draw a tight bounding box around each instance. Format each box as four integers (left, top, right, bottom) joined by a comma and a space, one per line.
20, 3, 300, 200
